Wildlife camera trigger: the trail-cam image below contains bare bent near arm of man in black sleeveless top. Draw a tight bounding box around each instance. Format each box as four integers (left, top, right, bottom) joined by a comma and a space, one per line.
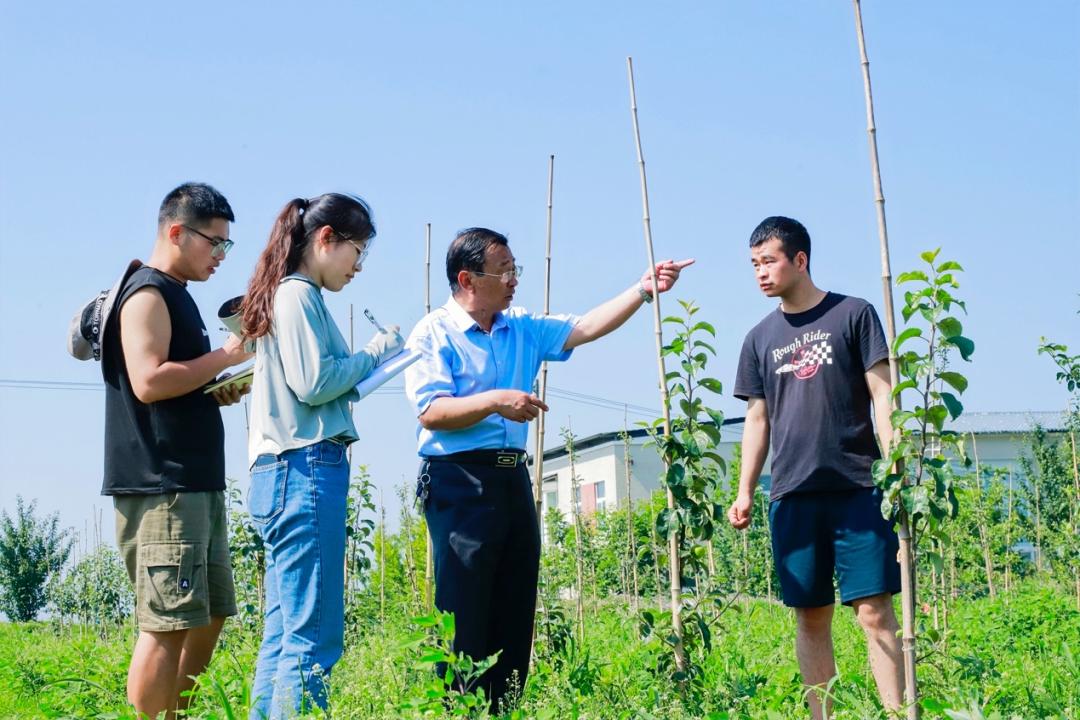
120, 287, 252, 403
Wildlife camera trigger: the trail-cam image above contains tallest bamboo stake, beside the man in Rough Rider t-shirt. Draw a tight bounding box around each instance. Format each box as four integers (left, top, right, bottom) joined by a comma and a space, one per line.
852, 0, 921, 720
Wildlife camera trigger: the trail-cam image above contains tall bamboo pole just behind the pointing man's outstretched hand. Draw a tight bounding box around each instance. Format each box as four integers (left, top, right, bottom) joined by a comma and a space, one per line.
626, 57, 687, 673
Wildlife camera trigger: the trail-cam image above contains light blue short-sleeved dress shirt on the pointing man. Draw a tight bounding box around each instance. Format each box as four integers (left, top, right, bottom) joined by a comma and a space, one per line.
405, 297, 578, 457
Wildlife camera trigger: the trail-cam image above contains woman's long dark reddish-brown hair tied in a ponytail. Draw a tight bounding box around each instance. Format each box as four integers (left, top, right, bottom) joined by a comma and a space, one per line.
241, 192, 375, 340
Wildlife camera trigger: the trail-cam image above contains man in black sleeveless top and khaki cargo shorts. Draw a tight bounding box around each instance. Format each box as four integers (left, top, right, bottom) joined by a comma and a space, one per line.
102, 184, 251, 718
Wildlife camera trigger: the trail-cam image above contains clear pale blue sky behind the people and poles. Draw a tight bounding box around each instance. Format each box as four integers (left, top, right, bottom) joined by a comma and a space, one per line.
0, 0, 1080, 539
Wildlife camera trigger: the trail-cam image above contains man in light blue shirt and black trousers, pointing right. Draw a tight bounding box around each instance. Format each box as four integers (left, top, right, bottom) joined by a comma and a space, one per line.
405, 228, 693, 709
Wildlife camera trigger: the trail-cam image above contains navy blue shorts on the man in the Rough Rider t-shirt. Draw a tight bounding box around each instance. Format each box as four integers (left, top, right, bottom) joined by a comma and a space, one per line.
769, 488, 900, 608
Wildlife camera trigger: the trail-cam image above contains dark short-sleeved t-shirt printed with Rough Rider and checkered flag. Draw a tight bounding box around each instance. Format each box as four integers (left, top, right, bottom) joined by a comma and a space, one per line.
734, 293, 889, 500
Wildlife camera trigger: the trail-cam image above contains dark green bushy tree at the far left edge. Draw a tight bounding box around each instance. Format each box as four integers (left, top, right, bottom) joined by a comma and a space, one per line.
0, 495, 75, 622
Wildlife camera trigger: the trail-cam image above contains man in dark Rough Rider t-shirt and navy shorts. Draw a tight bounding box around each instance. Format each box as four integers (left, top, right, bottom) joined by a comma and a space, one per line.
728, 217, 904, 719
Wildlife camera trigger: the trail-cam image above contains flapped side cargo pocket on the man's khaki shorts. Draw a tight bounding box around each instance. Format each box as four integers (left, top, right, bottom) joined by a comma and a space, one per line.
136, 543, 207, 615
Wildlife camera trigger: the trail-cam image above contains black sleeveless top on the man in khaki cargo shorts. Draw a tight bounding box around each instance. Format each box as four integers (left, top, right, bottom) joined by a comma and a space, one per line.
102, 267, 225, 495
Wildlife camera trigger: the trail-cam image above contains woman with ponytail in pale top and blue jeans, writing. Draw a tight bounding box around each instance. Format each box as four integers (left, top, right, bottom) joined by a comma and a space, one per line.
243, 193, 404, 720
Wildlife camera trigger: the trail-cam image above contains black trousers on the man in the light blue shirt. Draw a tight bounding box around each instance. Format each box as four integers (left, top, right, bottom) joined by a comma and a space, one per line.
420, 462, 540, 709
